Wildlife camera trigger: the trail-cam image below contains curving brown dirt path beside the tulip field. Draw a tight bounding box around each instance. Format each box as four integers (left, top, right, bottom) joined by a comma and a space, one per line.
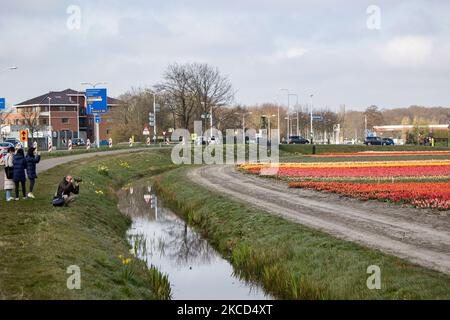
188, 166, 450, 274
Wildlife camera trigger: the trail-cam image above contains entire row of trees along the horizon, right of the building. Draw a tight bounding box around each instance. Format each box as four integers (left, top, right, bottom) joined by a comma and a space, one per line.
112, 63, 449, 141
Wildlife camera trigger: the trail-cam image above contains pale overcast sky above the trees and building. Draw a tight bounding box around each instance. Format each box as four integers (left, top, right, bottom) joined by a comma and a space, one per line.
0, 0, 450, 110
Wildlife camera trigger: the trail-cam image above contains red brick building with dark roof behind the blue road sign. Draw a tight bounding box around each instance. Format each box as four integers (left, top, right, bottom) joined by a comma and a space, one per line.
5, 89, 124, 146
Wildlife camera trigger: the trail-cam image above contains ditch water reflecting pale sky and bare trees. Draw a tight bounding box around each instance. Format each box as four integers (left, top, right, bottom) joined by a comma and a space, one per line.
119, 186, 271, 300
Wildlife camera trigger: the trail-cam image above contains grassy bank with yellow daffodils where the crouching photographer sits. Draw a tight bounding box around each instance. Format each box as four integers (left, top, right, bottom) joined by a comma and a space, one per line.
0, 150, 176, 299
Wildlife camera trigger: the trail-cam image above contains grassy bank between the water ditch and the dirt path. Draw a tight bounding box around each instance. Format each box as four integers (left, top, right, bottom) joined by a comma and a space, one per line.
155, 168, 450, 299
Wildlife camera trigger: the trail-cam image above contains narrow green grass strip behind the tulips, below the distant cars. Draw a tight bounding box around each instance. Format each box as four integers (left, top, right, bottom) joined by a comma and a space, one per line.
280, 144, 450, 154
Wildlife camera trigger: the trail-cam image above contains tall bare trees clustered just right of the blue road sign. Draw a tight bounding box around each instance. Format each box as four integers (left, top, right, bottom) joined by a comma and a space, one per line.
112, 63, 235, 140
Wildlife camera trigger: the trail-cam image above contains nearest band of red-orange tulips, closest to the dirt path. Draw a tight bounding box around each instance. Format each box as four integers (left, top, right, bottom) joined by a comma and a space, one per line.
289, 182, 450, 210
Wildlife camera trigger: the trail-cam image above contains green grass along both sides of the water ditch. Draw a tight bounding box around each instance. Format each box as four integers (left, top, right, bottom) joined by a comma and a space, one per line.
0, 150, 450, 299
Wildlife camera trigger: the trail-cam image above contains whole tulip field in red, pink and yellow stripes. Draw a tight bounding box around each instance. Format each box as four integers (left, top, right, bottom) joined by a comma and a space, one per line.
240, 153, 450, 210
